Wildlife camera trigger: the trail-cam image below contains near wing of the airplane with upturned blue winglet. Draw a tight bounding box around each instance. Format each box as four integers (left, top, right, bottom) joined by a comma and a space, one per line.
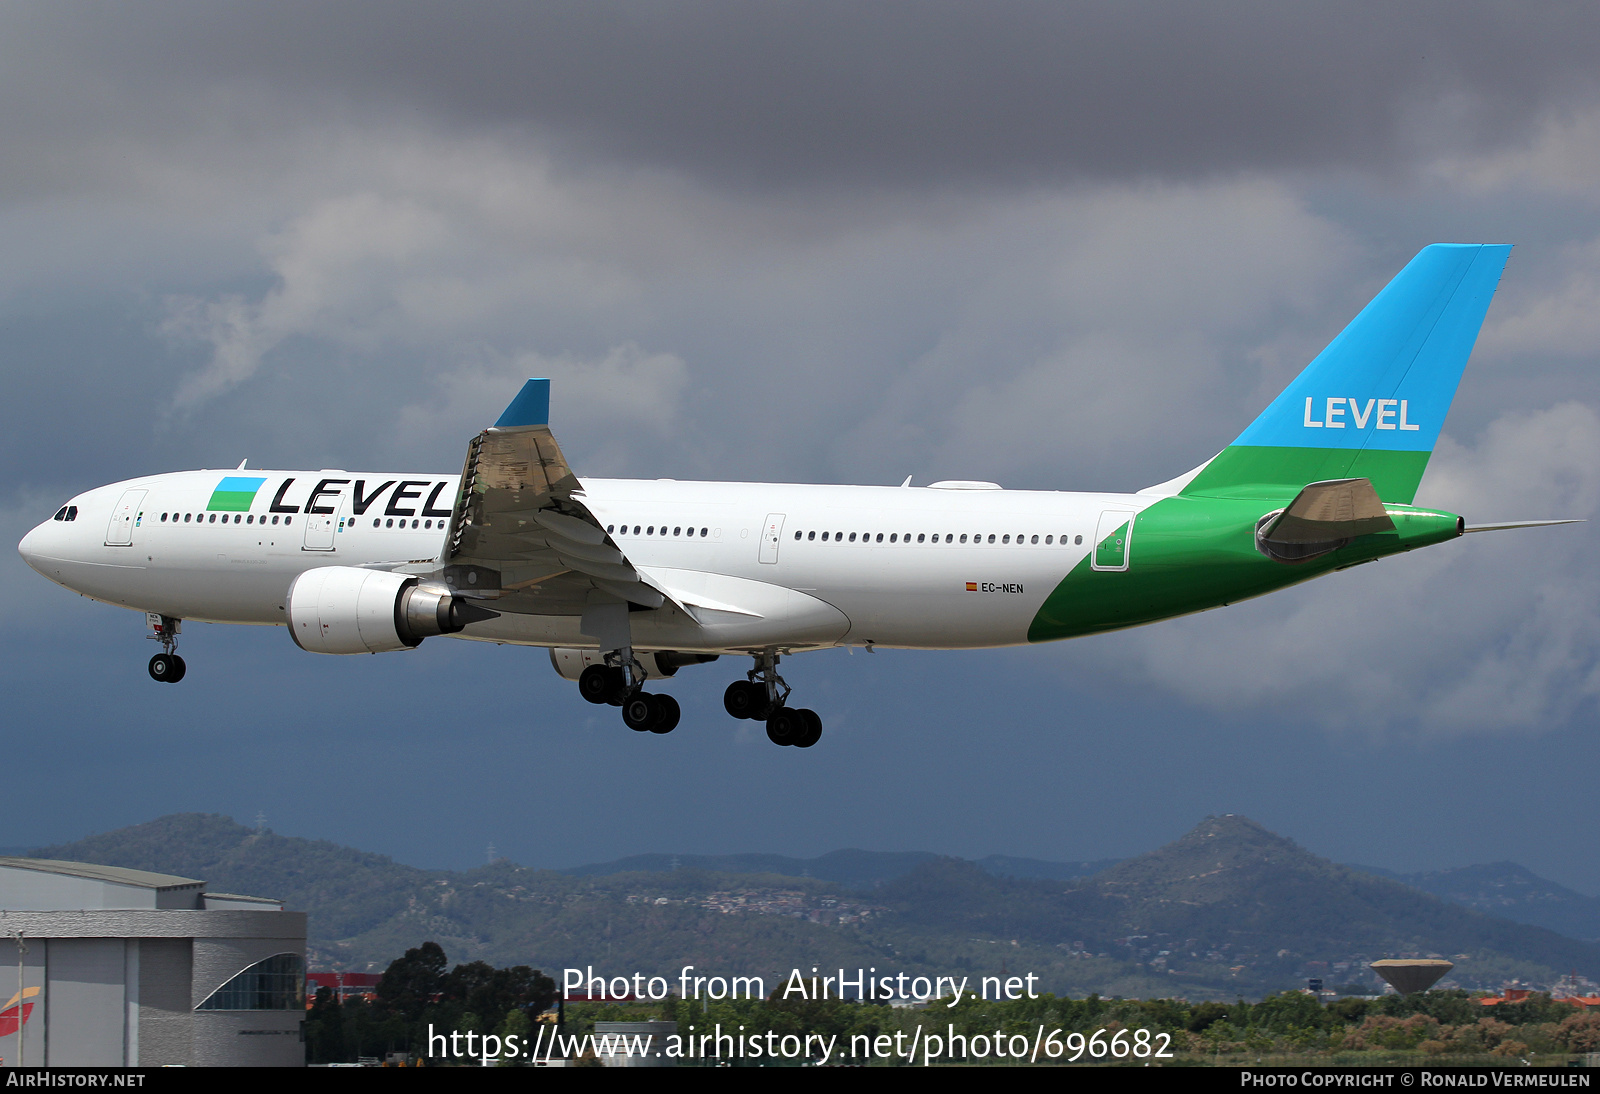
440, 379, 666, 616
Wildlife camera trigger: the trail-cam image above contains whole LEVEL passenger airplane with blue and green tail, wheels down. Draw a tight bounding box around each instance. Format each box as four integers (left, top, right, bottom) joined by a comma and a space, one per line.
19, 243, 1573, 749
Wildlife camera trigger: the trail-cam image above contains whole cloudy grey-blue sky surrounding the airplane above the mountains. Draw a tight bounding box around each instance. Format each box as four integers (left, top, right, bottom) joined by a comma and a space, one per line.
0, 3, 1600, 892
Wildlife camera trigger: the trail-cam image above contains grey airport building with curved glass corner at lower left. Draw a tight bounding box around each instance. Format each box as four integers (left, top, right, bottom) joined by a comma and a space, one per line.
0, 857, 306, 1067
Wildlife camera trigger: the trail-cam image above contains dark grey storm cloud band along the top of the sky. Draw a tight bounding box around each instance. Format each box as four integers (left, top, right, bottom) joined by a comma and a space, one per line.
5, 0, 1600, 184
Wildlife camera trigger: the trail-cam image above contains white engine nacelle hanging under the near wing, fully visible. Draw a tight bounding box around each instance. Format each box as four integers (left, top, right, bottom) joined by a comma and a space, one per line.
285, 566, 496, 654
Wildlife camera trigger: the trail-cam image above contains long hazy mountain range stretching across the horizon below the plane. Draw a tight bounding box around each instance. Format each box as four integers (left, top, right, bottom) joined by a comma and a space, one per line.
34, 814, 1600, 998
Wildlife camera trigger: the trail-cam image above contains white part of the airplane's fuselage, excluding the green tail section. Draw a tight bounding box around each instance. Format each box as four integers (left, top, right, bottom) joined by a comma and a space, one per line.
19, 470, 1157, 651
